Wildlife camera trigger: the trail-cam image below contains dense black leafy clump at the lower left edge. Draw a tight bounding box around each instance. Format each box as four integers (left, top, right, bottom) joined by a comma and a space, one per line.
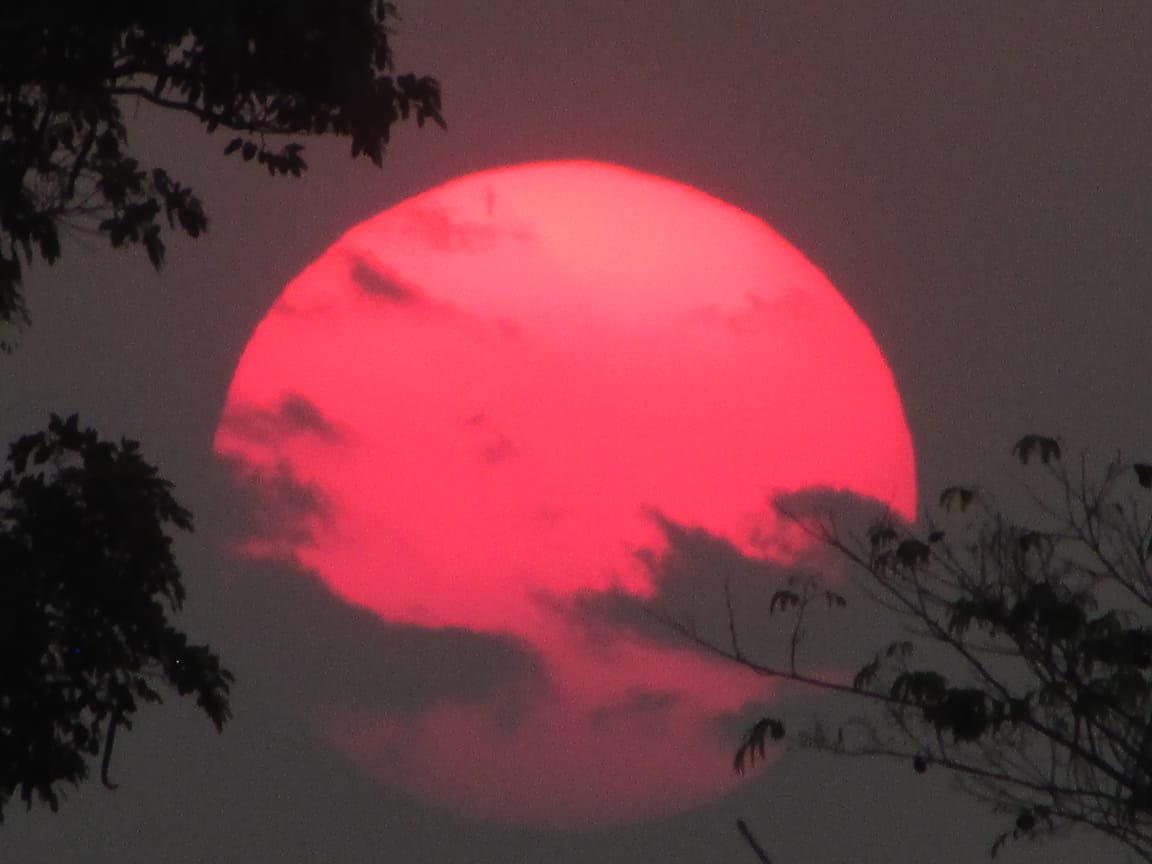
0, 415, 233, 818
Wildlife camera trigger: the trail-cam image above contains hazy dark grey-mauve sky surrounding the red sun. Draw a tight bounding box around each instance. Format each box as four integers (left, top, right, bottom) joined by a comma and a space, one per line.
0, 0, 1152, 864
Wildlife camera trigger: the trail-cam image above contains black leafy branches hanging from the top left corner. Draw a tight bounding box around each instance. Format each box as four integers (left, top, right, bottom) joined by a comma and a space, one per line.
0, 0, 444, 340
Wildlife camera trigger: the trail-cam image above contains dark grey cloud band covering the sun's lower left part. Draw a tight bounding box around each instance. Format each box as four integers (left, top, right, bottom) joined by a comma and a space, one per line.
209, 453, 551, 725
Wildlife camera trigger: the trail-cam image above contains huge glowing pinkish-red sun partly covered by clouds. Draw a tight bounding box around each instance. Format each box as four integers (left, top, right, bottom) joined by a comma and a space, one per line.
215, 162, 916, 826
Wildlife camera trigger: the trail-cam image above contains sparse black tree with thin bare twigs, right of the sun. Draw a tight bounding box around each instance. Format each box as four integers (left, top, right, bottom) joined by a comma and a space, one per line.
672, 435, 1152, 861
